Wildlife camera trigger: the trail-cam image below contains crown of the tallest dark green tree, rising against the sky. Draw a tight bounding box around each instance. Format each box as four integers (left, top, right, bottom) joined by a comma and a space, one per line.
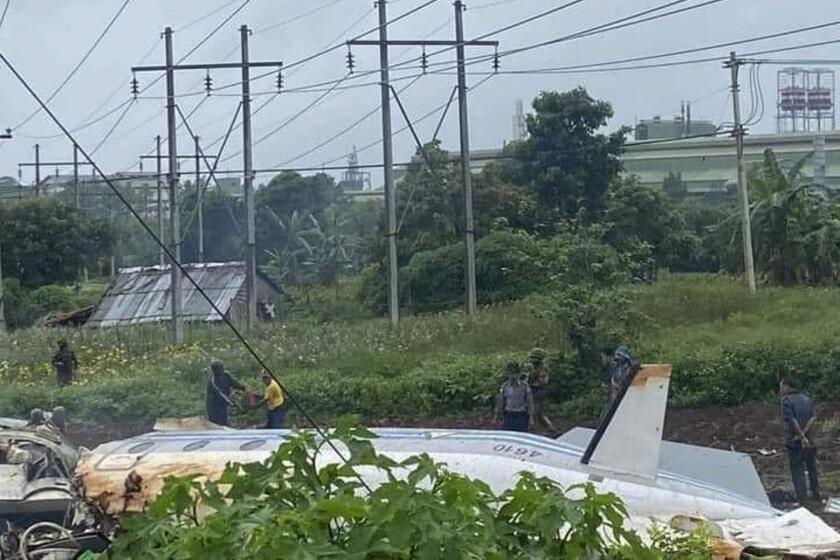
506, 88, 627, 221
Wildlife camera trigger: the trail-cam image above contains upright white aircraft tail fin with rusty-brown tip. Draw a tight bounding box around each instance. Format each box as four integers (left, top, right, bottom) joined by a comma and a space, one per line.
582, 364, 672, 478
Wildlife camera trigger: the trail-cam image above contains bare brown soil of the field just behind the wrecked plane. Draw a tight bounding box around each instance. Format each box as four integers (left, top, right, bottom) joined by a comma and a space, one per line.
71, 404, 840, 527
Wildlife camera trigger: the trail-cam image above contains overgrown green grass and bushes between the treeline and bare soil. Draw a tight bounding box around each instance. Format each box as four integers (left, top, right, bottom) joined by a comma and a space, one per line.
0, 275, 840, 423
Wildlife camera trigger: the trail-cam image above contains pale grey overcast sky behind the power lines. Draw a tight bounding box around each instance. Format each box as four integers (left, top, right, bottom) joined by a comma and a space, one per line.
0, 0, 840, 188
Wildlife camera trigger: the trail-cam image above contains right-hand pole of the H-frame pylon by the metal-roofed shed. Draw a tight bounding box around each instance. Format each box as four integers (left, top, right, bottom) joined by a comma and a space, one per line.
239, 25, 257, 328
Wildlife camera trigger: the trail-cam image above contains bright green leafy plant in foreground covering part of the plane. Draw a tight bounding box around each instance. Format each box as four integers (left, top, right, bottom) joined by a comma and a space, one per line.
101, 428, 712, 560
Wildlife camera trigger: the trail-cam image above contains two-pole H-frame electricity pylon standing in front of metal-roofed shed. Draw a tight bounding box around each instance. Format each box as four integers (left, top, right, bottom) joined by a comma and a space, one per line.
131, 25, 283, 344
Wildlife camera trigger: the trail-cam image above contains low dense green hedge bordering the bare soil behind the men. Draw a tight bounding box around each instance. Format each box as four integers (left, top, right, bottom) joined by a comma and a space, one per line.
0, 343, 840, 422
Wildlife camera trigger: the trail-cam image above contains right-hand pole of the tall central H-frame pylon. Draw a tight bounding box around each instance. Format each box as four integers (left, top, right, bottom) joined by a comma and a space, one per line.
455, 0, 478, 320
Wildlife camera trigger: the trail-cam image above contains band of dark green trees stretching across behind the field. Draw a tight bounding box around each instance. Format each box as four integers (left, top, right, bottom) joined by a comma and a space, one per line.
0, 88, 840, 330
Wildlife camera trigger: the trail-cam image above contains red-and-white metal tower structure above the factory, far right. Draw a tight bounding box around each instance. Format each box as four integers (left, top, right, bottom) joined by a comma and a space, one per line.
776, 67, 835, 133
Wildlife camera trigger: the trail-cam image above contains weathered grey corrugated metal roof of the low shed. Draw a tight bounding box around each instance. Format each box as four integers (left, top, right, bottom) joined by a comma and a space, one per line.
86, 262, 251, 327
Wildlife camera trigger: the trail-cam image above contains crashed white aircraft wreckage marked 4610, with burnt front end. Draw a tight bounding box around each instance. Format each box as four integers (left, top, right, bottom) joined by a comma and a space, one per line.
0, 365, 840, 560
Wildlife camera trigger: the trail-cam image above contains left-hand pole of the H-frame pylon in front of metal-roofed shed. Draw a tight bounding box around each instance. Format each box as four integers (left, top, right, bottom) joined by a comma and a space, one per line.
164, 27, 184, 345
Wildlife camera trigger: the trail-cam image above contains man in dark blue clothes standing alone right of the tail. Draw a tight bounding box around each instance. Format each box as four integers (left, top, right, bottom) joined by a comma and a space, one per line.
779, 377, 820, 505
